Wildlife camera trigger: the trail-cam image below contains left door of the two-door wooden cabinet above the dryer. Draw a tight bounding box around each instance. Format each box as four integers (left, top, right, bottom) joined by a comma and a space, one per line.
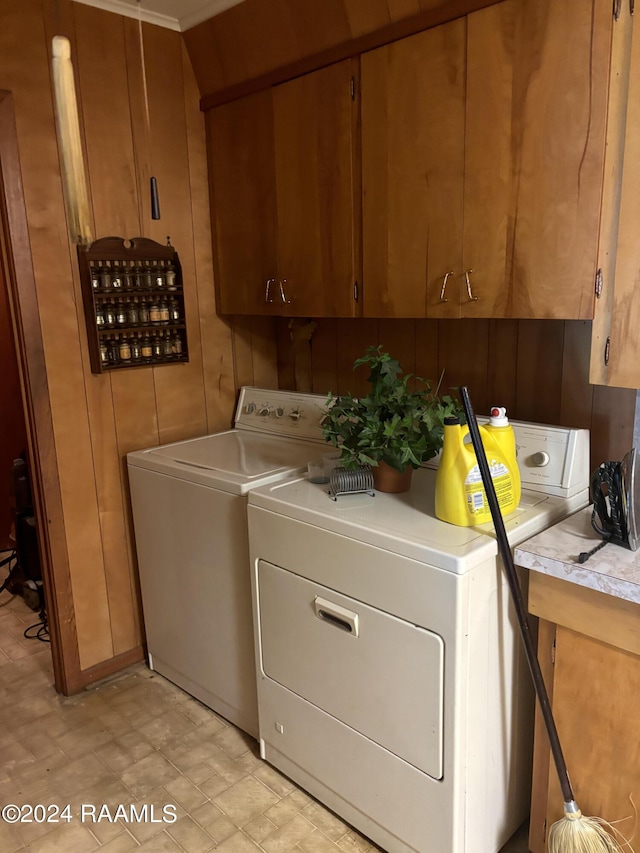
362, 19, 466, 317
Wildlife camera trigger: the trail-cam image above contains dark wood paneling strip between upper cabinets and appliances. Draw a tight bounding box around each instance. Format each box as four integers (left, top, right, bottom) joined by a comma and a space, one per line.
278, 319, 636, 469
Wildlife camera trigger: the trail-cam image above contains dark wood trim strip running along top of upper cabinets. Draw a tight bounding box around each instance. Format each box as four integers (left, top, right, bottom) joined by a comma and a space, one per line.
195, 0, 498, 111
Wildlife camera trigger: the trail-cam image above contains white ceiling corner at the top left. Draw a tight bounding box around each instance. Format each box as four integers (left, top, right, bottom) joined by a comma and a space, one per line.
74, 0, 248, 32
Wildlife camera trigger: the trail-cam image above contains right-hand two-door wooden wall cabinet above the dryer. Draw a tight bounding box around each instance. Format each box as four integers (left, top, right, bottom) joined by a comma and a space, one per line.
362, 0, 612, 319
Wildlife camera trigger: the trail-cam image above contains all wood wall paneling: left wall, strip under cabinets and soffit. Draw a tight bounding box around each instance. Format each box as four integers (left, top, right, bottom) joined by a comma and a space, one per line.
0, 0, 635, 691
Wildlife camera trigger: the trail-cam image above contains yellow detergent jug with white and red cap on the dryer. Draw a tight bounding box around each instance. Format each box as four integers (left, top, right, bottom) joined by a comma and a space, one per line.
436, 409, 520, 527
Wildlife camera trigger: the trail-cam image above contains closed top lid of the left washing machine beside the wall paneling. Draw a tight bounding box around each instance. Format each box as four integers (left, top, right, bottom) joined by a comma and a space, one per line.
127, 429, 322, 494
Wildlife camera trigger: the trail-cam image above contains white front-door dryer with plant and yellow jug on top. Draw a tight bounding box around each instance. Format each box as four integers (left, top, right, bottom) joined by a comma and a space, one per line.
248, 423, 589, 853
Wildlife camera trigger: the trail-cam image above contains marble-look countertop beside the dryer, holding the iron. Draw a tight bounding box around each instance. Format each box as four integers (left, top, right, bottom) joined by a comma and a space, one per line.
514, 507, 640, 604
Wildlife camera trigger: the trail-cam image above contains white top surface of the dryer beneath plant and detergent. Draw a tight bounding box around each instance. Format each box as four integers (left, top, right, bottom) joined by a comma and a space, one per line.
249, 468, 588, 574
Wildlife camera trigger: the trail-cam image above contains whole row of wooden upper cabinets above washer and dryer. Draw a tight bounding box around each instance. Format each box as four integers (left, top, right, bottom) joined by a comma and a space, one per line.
207, 0, 628, 324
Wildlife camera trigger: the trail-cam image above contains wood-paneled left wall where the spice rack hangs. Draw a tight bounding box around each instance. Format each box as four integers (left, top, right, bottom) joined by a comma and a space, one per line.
0, 0, 242, 690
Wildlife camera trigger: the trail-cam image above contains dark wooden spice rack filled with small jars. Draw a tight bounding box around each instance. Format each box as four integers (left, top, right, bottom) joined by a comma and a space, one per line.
78, 237, 189, 373
